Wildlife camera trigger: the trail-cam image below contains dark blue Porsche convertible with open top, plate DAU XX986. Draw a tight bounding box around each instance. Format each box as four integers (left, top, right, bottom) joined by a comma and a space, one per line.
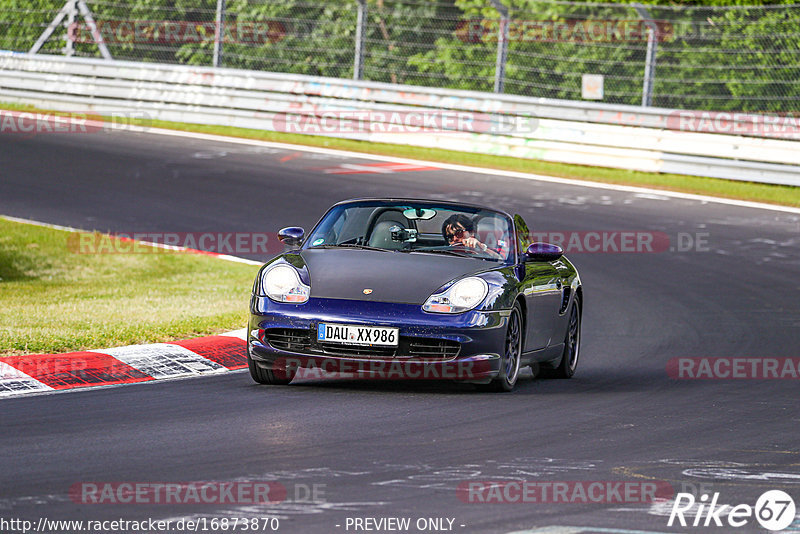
247, 199, 583, 391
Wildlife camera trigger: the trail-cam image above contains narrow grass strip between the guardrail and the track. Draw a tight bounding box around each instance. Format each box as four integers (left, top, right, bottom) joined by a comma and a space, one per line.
0, 104, 800, 206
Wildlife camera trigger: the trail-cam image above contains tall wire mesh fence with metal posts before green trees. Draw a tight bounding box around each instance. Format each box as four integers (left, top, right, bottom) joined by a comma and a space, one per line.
0, 0, 800, 114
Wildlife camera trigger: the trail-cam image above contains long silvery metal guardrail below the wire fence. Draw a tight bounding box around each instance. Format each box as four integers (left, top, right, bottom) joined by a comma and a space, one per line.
0, 53, 800, 186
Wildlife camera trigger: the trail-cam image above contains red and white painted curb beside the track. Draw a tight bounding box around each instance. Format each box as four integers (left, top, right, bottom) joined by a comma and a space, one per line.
0, 329, 247, 398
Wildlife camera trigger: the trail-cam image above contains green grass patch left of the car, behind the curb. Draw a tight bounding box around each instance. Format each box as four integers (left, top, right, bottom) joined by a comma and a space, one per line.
0, 218, 258, 356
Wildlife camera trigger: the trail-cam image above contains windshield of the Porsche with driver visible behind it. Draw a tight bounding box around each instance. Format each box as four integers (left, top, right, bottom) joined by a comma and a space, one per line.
304, 201, 513, 261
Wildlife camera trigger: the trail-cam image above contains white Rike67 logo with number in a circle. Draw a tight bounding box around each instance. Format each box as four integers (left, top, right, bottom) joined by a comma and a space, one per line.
667, 490, 795, 531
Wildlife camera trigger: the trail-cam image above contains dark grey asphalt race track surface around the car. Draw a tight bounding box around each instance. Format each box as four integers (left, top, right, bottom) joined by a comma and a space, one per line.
0, 133, 800, 533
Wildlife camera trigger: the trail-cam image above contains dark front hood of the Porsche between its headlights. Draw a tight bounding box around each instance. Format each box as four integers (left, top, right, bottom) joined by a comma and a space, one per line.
300, 248, 493, 305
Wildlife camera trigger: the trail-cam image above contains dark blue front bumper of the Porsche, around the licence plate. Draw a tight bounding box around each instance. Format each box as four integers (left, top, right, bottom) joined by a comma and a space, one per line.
248, 297, 510, 383
